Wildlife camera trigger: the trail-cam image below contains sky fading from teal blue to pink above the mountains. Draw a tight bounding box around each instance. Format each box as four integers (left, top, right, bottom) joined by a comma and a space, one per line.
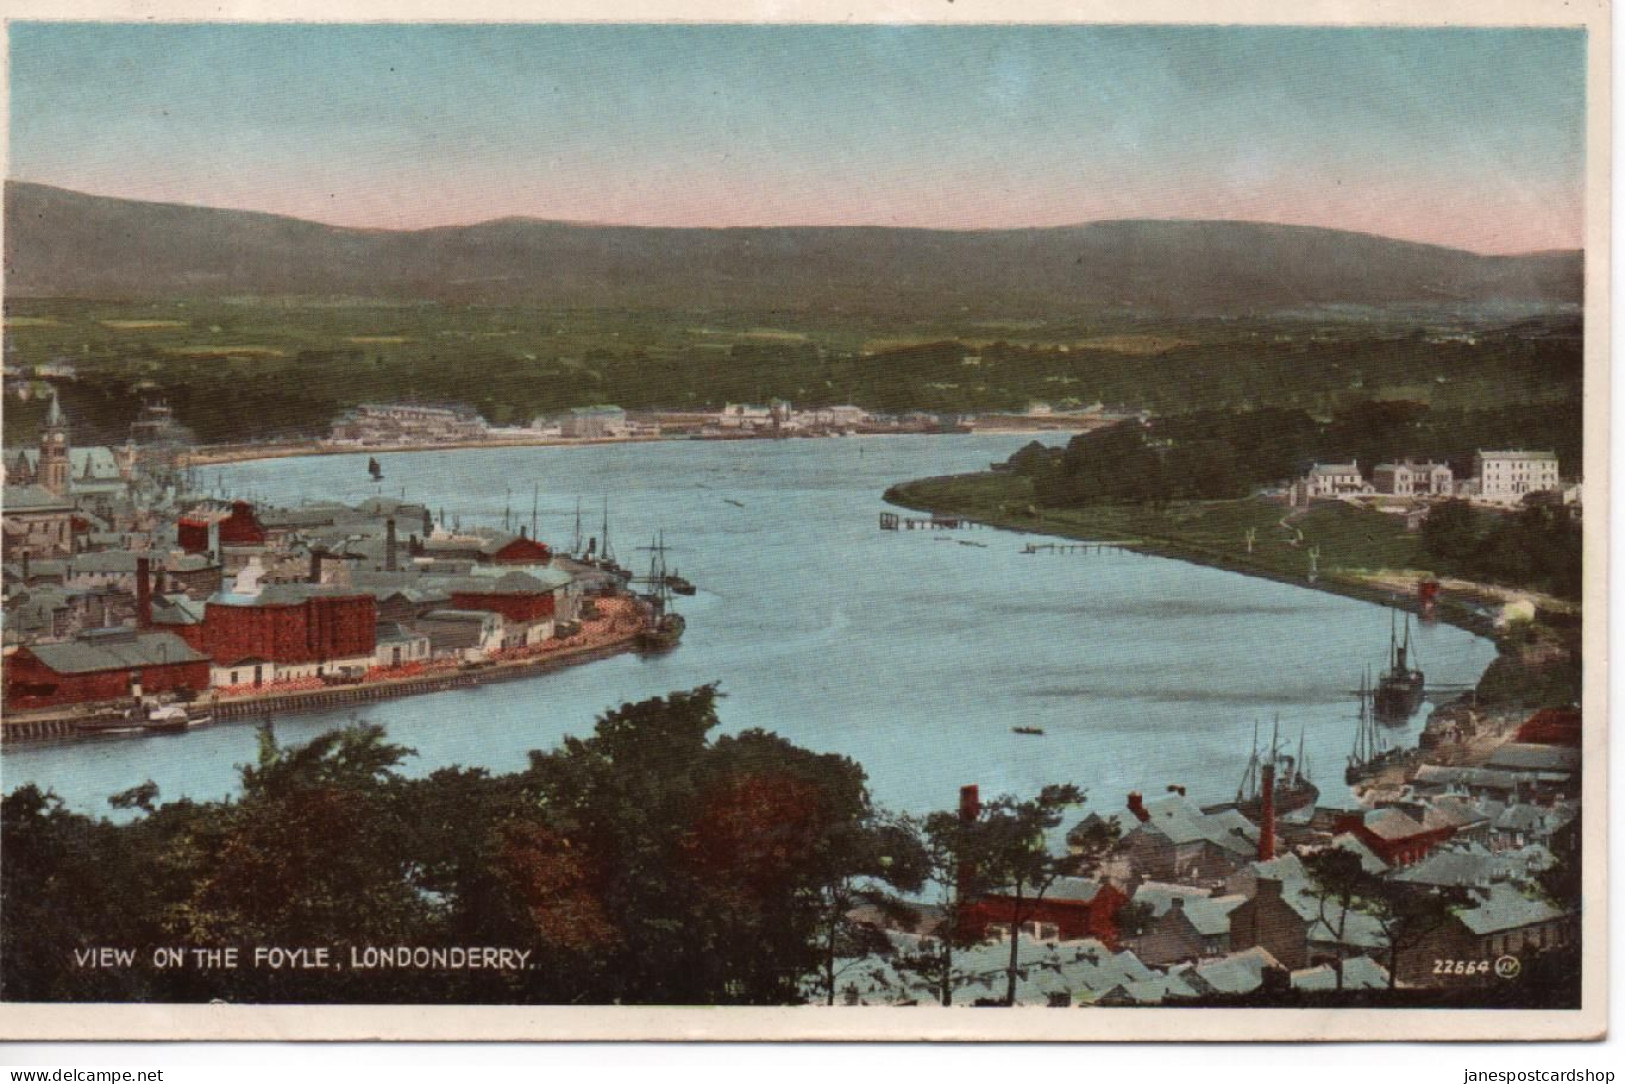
10, 23, 1586, 252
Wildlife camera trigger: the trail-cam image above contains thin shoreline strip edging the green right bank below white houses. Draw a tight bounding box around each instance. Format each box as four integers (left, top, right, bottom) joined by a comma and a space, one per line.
882, 475, 1502, 645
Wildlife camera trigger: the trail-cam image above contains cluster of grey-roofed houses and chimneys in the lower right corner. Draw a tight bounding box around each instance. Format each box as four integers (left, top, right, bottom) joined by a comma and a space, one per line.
842, 715, 1580, 1004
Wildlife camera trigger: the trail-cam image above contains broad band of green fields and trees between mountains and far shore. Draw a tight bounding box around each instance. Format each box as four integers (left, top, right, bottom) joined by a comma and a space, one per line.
5, 297, 1581, 442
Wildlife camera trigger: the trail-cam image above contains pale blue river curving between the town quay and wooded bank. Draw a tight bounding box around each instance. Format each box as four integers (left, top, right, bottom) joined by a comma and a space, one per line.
0, 434, 1495, 816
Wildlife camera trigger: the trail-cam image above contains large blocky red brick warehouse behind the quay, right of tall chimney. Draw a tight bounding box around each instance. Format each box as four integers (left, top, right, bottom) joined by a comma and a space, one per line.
202, 583, 379, 665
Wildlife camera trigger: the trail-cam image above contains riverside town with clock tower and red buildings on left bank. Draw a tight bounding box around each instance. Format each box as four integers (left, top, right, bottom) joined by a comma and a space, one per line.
3, 400, 692, 739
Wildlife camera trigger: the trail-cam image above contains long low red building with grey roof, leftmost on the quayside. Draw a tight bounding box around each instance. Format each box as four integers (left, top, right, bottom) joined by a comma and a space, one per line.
5, 629, 210, 712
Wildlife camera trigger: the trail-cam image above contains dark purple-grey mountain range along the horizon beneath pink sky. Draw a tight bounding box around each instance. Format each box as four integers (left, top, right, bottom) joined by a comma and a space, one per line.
5, 182, 1584, 315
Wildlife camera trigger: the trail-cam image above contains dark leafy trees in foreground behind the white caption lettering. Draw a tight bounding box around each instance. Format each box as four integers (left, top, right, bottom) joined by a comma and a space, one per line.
0, 686, 1105, 1004
